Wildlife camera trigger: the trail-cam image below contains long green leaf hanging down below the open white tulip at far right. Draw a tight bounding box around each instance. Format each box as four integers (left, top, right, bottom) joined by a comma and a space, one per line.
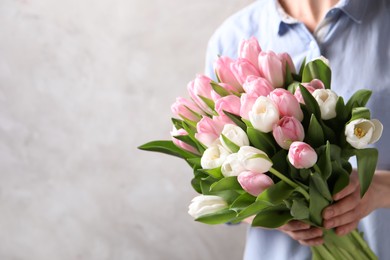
355, 148, 378, 197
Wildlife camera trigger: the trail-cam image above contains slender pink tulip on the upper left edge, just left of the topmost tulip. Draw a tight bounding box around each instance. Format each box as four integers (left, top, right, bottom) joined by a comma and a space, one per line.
214, 56, 241, 91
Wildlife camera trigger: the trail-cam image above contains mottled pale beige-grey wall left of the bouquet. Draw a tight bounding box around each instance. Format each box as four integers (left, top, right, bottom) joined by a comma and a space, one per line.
0, 0, 252, 260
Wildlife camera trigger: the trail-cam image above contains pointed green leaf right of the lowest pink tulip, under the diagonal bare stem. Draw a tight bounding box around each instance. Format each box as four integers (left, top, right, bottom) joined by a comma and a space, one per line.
256, 181, 295, 205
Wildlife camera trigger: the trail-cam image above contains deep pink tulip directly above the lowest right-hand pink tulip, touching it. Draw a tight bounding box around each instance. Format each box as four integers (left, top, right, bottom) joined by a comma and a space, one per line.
272, 116, 305, 150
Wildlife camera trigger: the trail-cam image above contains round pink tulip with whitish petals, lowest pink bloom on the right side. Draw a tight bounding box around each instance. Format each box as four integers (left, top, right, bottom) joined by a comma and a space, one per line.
288, 142, 317, 169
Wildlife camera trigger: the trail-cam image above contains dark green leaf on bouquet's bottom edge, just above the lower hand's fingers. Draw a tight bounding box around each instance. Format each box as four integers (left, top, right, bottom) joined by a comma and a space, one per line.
252, 205, 293, 228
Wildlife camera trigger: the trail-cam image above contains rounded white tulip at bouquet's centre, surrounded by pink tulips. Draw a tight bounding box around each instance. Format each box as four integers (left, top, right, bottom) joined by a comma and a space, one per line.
249, 96, 279, 133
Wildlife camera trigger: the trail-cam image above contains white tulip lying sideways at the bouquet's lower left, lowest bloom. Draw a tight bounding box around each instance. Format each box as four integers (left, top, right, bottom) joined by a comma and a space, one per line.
188, 195, 228, 219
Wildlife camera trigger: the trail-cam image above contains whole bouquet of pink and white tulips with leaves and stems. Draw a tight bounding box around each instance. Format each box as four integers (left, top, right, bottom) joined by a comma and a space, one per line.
139, 38, 382, 260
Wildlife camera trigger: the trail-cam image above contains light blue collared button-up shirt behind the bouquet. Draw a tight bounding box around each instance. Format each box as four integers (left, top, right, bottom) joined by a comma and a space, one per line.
206, 0, 390, 260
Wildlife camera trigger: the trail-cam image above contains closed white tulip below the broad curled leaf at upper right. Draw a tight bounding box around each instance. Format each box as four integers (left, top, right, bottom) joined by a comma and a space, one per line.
312, 89, 338, 120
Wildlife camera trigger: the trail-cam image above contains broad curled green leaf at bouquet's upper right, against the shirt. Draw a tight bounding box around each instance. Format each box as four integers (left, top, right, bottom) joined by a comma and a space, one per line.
302, 59, 332, 89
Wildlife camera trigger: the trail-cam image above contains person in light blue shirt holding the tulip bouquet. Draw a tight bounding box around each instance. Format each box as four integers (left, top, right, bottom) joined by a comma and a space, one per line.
206, 0, 390, 260
